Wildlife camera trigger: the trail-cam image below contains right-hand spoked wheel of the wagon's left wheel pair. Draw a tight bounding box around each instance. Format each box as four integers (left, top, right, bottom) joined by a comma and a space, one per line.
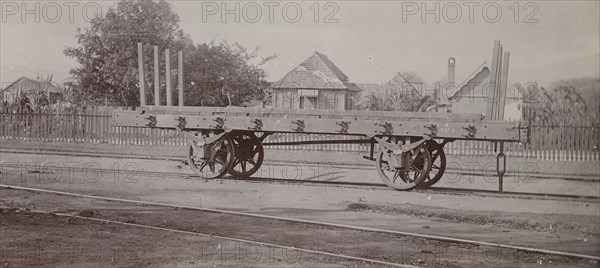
228, 131, 265, 177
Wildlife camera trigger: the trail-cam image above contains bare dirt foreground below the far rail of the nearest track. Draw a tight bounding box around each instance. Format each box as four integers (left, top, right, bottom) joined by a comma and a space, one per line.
0, 190, 598, 267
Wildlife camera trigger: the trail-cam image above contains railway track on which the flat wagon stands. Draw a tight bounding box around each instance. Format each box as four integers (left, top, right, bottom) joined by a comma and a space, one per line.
4, 157, 600, 202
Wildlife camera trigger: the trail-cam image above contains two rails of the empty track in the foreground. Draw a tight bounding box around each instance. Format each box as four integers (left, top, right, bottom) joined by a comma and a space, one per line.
0, 185, 600, 267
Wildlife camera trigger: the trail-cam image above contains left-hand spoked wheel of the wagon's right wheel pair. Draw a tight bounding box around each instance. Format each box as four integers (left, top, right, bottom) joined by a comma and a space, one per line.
376, 140, 431, 191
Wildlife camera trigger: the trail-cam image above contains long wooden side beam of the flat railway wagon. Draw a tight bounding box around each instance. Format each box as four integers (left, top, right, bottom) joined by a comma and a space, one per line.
113, 111, 527, 142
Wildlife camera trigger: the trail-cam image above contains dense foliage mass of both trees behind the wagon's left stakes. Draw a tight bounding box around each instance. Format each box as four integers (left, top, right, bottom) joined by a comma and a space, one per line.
64, 0, 273, 106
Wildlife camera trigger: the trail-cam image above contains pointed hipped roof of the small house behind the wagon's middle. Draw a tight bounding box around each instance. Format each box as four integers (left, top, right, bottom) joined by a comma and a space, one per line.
273, 51, 360, 91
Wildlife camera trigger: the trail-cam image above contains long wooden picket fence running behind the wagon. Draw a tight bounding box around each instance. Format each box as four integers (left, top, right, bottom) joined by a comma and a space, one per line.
0, 110, 600, 161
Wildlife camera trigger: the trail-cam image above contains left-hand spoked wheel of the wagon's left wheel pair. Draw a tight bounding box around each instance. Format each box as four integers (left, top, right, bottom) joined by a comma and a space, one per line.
188, 131, 235, 179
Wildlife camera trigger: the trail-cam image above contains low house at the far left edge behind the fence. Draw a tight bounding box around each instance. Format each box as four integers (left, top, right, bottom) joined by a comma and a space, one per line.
2, 76, 62, 103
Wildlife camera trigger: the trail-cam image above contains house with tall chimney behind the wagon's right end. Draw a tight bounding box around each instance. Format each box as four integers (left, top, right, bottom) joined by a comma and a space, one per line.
435, 58, 522, 120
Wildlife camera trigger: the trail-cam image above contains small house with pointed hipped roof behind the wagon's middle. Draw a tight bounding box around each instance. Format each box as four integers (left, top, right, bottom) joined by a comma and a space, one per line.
272, 51, 360, 110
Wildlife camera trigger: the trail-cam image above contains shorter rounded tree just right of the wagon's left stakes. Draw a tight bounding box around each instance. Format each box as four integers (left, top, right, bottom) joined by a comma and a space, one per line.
184, 42, 276, 106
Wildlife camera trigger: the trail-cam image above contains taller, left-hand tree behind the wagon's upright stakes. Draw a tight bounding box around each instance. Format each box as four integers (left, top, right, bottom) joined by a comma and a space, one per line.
64, 0, 192, 106
